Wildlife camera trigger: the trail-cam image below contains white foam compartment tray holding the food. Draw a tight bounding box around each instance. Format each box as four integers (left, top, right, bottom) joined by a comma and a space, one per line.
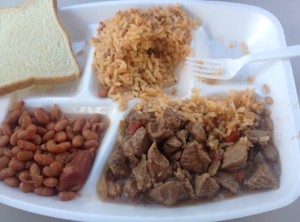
0, 0, 300, 222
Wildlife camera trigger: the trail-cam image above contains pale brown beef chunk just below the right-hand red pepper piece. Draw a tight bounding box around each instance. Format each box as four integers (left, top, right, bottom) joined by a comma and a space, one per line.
221, 143, 248, 171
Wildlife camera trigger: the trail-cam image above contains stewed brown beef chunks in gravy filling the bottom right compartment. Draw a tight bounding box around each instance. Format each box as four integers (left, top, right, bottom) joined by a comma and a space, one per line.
98, 104, 280, 206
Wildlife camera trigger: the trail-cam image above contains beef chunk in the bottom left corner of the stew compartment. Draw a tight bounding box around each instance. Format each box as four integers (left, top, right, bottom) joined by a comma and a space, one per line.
97, 172, 122, 200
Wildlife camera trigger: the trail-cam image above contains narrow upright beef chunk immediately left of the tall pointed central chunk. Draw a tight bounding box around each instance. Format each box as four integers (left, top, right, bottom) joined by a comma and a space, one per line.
132, 155, 152, 191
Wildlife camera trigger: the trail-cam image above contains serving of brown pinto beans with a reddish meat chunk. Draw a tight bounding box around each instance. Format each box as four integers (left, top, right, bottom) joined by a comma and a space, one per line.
0, 101, 109, 200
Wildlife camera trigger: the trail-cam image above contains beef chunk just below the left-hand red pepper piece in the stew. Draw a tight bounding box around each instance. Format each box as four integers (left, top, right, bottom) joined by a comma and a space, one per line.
124, 127, 151, 162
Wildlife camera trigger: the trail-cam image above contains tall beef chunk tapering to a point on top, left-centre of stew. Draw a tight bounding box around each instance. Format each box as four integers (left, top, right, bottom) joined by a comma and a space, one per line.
147, 142, 170, 183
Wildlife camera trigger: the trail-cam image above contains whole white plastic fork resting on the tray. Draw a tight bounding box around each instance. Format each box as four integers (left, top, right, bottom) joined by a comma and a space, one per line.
185, 45, 300, 80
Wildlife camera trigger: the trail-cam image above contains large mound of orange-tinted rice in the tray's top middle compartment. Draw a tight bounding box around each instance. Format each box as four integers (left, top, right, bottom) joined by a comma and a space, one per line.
92, 5, 199, 109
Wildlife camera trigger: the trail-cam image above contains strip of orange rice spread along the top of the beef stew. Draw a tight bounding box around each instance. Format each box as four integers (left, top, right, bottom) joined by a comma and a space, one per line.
135, 89, 270, 149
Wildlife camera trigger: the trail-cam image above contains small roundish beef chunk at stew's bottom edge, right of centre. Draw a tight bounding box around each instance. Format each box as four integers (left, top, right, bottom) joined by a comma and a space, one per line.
194, 173, 220, 198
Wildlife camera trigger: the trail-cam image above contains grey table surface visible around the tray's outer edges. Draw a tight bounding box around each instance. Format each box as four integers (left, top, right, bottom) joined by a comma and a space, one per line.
0, 0, 300, 222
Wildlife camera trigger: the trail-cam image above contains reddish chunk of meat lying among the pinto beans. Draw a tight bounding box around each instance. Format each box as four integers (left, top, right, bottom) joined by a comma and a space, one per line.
59, 148, 95, 191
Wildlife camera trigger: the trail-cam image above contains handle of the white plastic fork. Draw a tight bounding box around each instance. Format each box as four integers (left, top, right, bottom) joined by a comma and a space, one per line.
242, 45, 300, 62
